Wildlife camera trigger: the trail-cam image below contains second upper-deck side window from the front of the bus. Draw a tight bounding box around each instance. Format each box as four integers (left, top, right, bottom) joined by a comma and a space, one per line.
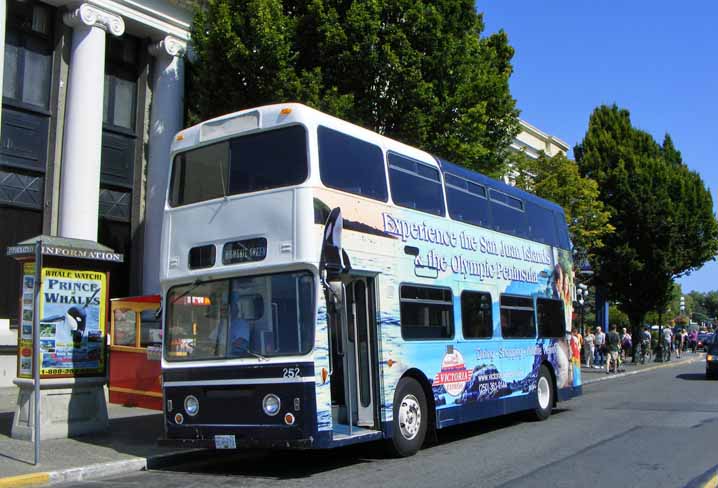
389, 153, 444, 216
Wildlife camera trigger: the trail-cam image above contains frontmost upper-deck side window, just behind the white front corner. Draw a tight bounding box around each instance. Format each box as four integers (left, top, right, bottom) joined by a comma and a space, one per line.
317, 126, 387, 202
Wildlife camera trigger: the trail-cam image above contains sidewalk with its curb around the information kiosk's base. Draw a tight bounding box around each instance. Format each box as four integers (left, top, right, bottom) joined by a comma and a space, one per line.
0, 387, 210, 488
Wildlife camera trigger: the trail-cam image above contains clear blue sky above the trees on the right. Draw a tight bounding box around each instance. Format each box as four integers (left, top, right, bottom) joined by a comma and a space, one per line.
476, 0, 718, 292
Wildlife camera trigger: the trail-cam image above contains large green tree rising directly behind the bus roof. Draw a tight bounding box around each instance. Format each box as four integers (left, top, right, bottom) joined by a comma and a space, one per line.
188, 0, 519, 176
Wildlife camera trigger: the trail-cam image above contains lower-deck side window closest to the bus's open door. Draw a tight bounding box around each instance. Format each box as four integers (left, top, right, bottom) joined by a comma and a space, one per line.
400, 285, 454, 340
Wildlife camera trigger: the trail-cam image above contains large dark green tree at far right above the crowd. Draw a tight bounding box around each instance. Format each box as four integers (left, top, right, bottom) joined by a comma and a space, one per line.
574, 105, 718, 352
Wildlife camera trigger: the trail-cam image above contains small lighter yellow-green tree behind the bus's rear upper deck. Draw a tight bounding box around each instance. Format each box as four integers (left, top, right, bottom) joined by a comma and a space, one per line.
511, 152, 613, 265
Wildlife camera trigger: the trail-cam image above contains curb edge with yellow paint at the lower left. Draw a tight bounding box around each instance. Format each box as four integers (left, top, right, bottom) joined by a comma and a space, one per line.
0, 449, 213, 488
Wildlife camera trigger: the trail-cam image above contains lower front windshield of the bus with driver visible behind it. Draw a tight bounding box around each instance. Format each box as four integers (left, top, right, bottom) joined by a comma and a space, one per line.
165, 272, 315, 361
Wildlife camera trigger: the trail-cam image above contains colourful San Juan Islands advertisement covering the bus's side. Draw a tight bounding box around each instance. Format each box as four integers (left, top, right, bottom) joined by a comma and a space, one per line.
315, 191, 580, 430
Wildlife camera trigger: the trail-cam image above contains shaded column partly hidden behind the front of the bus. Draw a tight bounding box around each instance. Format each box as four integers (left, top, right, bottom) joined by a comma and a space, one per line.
142, 36, 187, 294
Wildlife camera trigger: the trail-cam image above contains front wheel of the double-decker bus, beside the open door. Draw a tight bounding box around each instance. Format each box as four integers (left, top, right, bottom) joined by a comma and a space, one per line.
388, 377, 430, 457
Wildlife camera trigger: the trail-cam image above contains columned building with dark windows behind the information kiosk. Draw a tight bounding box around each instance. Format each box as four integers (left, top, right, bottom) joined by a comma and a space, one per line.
0, 0, 193, 327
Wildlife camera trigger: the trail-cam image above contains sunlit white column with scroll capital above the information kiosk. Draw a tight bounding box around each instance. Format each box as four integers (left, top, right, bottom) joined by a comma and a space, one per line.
59, 3, 125, 241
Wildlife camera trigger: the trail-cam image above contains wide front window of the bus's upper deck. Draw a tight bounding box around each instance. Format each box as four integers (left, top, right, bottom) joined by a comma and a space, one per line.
170, 125, 309, 207
